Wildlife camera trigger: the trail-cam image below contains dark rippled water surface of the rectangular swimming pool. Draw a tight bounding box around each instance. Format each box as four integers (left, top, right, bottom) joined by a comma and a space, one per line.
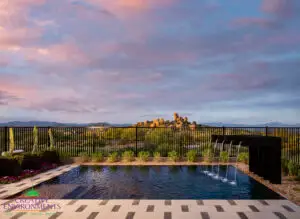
32, 166, 283, 199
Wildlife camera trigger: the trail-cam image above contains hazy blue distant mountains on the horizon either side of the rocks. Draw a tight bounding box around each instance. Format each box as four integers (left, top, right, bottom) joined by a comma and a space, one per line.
0, 121, 300, 127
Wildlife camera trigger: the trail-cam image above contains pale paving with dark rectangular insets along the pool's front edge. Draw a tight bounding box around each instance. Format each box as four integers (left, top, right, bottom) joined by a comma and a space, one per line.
0, 199, 300, 219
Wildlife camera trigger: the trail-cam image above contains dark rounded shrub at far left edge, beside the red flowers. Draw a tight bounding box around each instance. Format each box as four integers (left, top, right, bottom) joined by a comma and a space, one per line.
0, 157, 22, 176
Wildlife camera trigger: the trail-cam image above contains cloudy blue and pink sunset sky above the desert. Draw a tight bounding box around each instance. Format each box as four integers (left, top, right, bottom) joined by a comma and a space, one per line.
0, 0, 300, 124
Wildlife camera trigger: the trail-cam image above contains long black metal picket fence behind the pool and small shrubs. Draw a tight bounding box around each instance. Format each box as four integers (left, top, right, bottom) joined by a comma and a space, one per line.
0, 127, 300, 164
